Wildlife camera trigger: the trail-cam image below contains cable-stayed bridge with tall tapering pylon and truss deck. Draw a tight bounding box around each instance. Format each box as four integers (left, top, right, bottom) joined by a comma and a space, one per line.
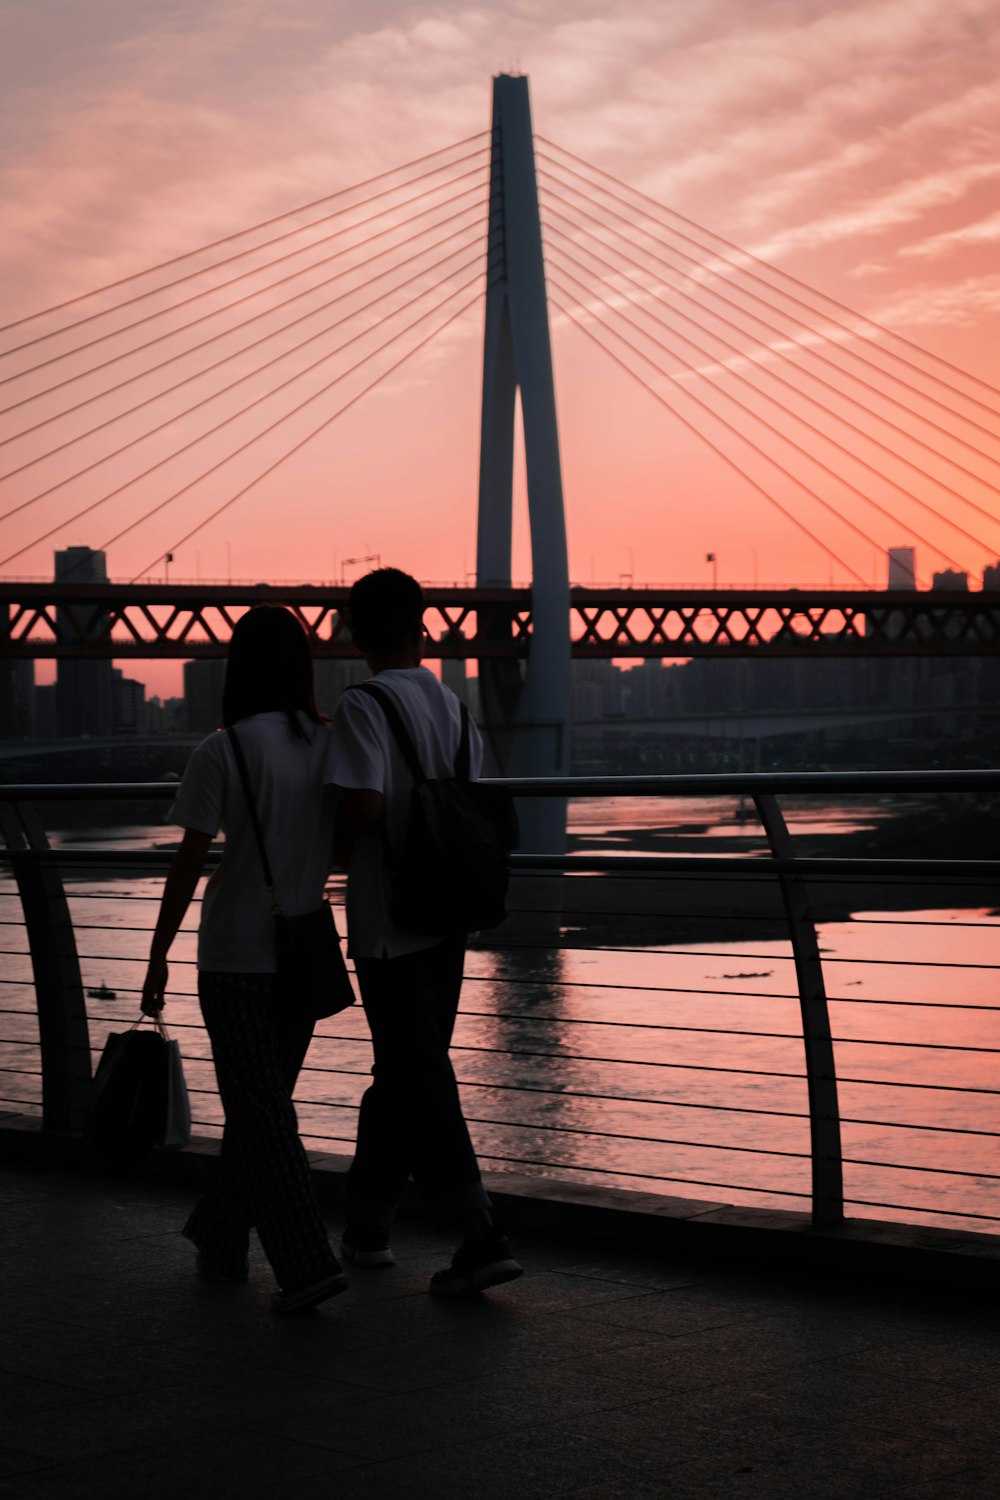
0, 77, 1000, 798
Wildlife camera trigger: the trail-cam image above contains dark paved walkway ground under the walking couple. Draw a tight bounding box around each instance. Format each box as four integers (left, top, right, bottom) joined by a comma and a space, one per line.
0, 1167, 1000, 1500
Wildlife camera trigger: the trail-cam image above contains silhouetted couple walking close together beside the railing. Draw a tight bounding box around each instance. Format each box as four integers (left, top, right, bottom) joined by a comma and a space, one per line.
142, 569, 522, 1311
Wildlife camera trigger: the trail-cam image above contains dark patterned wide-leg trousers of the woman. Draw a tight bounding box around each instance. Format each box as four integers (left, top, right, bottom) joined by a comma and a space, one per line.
183, 974, 337, 1290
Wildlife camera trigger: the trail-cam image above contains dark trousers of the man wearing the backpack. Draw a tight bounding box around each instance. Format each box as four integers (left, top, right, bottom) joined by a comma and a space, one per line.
346, 938, 489, 1226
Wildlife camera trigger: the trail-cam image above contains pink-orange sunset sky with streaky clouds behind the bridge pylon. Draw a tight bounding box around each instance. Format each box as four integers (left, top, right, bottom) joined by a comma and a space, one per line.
0, 0, 1000, 690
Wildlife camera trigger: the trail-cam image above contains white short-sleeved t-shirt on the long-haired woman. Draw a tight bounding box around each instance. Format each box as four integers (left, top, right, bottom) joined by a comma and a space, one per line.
169, 711, 334, 974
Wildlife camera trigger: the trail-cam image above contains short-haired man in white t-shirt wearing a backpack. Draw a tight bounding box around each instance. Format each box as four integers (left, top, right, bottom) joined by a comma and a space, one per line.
331, 569, 522, 1296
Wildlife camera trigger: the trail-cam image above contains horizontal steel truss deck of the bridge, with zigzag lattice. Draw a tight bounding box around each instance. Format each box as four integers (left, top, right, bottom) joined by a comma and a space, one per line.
0, 581, 1000, 660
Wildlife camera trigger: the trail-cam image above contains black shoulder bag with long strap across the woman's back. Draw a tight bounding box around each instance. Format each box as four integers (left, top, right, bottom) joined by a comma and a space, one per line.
226, 726, 354, 1022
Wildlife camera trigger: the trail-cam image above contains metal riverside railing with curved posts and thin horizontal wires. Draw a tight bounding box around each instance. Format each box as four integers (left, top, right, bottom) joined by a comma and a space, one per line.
0, 771, 1000, 1229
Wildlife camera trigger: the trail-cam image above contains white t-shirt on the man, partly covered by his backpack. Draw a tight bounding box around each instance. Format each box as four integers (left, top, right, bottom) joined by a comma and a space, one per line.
330, 666, 483, 959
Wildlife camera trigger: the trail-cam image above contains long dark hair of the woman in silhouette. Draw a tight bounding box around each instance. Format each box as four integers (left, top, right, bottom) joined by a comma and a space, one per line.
222, 605, 324, 737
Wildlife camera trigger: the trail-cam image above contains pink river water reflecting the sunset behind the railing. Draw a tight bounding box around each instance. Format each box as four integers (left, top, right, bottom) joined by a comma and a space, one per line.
0, 800, 1000, 1230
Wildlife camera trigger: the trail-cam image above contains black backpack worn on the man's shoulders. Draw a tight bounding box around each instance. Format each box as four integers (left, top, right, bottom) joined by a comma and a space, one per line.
351, 683, 517, 938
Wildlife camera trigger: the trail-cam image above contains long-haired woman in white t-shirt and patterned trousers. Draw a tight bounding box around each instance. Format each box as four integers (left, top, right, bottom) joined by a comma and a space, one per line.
141, 605, 346, 1313
